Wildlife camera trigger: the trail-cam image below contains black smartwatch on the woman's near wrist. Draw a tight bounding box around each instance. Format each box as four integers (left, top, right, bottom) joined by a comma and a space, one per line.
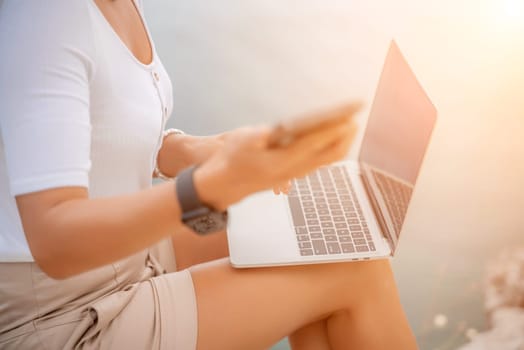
176, 166, 227, 235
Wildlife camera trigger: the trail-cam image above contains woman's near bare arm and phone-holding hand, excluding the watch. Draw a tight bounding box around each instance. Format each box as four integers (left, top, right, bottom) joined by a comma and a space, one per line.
16, 109, 355, 278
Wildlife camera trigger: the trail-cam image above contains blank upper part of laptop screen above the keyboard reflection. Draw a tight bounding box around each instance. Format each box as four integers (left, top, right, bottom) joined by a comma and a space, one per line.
359, 42, 437, 185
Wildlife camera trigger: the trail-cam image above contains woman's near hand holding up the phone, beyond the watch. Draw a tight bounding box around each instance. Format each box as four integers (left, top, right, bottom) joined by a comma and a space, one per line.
195, 105, 356, 209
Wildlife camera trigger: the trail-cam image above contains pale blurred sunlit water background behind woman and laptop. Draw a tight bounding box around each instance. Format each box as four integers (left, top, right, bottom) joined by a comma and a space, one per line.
145, 0, 524, 350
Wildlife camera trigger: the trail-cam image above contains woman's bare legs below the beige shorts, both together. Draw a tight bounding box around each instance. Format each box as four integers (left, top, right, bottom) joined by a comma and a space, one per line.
173, 231, 416, 350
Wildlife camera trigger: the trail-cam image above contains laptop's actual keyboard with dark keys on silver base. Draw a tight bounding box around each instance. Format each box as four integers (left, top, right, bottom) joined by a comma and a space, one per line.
288, 166, 376, 256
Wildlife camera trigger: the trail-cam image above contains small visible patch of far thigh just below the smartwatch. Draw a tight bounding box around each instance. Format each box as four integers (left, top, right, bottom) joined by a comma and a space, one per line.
171, 230, 229, 271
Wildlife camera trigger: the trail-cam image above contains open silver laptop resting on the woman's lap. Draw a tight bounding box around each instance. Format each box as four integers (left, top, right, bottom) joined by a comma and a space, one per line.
228, 42, 437, 267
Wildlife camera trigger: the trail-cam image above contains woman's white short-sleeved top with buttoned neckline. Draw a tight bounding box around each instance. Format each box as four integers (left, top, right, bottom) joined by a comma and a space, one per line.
0, 0, 173, 262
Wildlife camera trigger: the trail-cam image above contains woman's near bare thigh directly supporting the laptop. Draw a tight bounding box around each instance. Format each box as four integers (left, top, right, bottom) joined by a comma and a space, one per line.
190, 259, 409, 350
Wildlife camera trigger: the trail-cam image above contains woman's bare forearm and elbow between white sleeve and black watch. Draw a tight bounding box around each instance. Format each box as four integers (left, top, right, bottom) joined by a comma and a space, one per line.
17, 183, 182, 278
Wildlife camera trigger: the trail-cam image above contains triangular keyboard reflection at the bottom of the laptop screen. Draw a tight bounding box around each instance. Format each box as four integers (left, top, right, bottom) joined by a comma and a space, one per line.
371, 169, 413, 238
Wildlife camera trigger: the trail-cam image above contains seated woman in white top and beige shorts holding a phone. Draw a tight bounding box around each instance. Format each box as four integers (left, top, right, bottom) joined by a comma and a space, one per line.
0, 0, 416, 350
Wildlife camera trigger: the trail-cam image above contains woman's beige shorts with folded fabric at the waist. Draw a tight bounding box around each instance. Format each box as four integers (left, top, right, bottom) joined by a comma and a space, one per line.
0, 239, 197, 350
